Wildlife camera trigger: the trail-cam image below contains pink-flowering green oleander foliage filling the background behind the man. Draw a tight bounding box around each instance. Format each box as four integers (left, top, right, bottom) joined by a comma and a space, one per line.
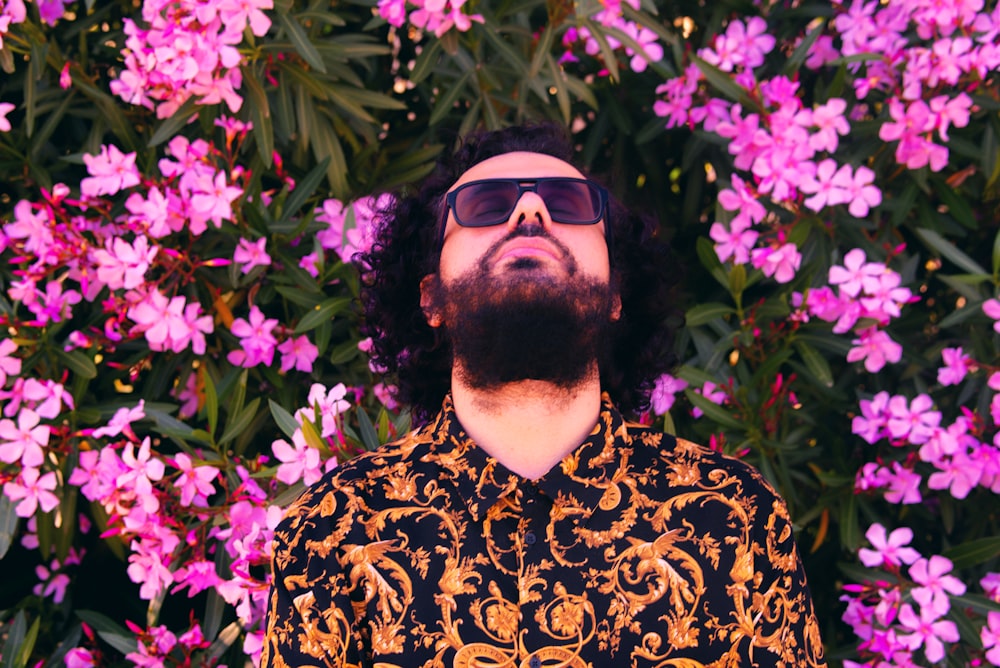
0, 0, 1000, 666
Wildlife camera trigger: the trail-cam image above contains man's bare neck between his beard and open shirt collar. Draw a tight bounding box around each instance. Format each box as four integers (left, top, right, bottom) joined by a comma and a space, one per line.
452, 365, 601, 480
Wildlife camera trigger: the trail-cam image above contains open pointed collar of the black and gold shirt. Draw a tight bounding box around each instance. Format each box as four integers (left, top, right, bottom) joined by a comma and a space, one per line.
425, 394, 631, 521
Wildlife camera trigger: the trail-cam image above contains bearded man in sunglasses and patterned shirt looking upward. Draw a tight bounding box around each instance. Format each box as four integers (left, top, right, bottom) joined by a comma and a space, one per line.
264, 126, 825, 668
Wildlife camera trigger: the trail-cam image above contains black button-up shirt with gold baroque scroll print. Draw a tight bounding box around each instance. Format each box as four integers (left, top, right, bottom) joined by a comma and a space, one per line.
263, 396, 826, 668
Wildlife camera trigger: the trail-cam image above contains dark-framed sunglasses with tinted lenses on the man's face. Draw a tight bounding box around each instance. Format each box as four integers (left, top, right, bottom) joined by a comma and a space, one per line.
445, 176, 608, 227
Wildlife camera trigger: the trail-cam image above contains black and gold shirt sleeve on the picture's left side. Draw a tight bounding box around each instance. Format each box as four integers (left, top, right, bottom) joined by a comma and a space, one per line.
261, 490, 361, 668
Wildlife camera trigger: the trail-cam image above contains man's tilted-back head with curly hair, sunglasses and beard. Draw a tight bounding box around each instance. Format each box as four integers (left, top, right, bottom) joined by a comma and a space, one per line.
361, 125, 676, 421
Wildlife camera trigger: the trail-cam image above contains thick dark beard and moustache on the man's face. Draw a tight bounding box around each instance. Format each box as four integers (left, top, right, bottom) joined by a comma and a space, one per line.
431, 232, 617, 390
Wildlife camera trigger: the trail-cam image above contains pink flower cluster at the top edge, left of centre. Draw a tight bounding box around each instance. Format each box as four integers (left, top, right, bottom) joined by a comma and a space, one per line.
111, 0, 274, 118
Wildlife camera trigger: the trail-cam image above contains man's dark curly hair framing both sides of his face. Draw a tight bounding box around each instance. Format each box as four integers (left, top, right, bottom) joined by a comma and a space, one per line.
355, 123, 683, 424
